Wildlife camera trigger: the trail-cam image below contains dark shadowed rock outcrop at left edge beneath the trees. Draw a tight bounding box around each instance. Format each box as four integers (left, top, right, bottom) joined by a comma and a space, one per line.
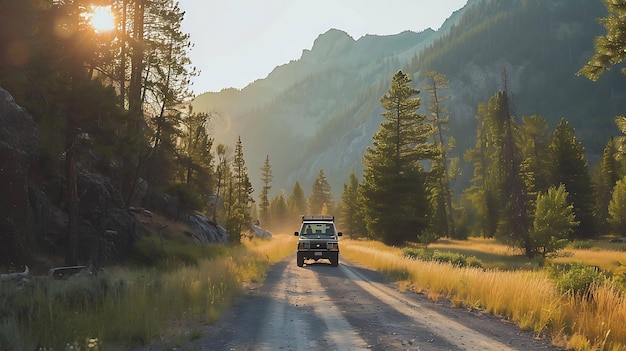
0, 88, 136, 266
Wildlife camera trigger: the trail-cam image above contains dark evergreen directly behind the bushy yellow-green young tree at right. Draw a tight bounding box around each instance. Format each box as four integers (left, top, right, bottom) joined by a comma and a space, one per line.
550, 118, 595, 239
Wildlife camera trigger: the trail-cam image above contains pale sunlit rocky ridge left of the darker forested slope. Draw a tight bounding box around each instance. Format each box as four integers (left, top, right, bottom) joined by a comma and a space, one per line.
193, 1, 473, 192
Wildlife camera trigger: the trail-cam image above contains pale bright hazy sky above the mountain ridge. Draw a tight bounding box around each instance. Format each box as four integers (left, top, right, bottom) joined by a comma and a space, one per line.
179, 0, 467, 94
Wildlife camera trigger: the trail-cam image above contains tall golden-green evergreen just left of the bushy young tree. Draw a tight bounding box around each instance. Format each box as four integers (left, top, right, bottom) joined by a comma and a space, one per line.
465, 92, 533, 257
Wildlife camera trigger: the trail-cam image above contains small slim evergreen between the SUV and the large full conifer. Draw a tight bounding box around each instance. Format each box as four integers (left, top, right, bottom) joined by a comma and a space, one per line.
339, 170, 365, 238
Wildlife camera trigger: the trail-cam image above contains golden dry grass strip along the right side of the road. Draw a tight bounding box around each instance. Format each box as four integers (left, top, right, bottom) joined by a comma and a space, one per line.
342, 239, 626, 350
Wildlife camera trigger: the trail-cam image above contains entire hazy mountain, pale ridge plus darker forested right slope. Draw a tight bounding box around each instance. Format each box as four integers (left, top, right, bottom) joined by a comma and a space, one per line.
193, 0, 626, 200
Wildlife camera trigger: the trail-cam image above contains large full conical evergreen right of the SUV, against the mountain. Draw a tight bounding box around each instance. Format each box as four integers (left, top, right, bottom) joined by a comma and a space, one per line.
360, 71, 436, 244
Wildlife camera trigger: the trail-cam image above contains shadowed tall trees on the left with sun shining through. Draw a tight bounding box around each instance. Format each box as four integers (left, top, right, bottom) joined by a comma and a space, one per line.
0, 0, 252, 264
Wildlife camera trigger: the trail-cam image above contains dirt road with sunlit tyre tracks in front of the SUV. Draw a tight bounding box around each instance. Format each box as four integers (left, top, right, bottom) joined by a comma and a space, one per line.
147, 257, 558, 351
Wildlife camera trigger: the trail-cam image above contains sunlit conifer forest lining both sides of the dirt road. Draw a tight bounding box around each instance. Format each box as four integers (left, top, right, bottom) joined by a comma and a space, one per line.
0, 0, 626, 267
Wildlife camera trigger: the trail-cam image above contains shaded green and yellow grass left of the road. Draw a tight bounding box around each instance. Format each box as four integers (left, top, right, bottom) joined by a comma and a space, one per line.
0, 232, 295, 350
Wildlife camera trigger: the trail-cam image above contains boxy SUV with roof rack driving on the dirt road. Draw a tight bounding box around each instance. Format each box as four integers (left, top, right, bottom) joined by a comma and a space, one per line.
294, 216, 341, 267
